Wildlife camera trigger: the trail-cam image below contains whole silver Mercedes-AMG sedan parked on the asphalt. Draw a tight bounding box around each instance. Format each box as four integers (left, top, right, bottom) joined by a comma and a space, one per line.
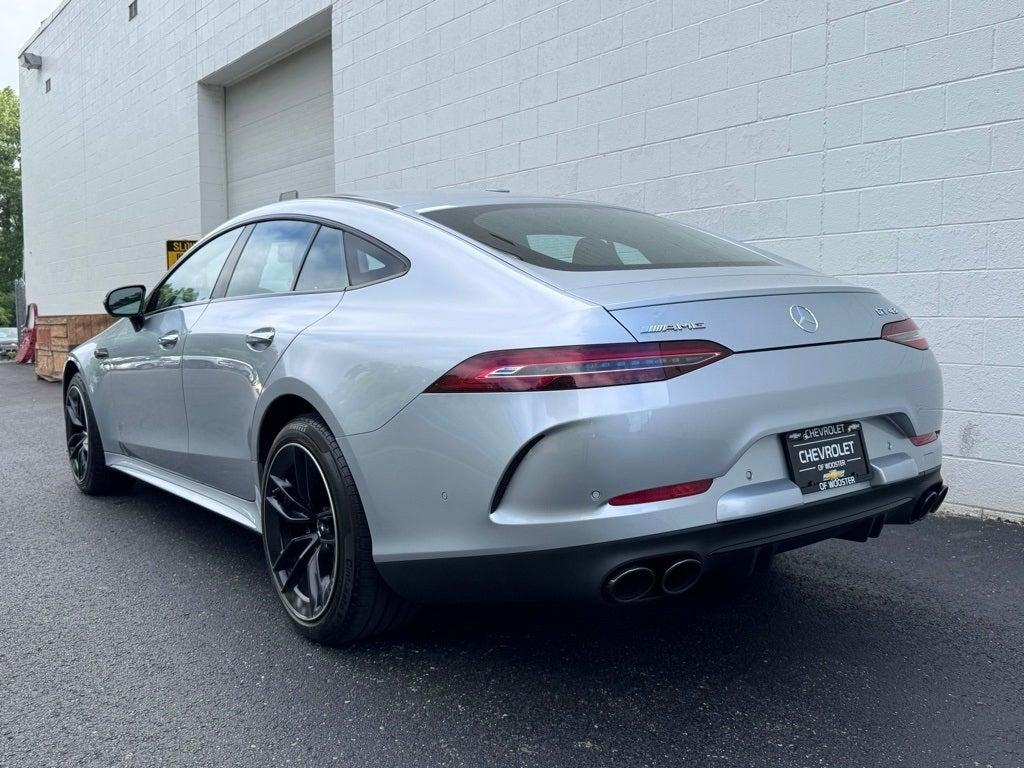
63, 191, 946, 644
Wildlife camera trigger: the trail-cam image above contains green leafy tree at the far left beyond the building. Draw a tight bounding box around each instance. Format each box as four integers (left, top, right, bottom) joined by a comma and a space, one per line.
0, 86, 24, 326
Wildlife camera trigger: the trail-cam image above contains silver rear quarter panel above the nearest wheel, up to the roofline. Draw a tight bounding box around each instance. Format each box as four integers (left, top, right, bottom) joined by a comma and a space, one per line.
257, 206, 633, 442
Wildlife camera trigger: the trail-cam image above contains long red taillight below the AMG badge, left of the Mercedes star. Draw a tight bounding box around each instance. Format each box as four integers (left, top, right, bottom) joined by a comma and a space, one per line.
426, 341, 732, 392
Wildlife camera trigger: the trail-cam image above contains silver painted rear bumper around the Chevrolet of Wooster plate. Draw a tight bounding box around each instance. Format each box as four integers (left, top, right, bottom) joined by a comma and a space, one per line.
340, 340, 942, 563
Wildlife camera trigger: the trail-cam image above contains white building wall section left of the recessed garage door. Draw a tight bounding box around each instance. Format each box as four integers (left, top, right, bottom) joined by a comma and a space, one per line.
19, 0, 331, 314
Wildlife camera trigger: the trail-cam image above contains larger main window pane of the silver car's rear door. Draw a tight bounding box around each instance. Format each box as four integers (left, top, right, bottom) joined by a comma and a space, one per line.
225, 221, 316, 296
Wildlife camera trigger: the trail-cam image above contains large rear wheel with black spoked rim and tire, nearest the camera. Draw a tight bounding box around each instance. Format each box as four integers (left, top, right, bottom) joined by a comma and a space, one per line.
260, 416, 414, 645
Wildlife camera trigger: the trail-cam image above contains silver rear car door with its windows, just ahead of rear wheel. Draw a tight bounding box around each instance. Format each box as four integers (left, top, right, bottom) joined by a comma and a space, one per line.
183, 219, 347, 501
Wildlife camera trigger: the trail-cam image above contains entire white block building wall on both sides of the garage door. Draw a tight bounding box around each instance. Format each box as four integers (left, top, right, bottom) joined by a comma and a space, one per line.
22, 0, 1024, 520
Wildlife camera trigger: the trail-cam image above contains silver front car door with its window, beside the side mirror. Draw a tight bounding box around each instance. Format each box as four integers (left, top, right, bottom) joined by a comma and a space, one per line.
100, 230, 240, 472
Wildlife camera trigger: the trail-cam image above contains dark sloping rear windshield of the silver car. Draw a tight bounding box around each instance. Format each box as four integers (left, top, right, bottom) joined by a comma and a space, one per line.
423, 203, 775, 271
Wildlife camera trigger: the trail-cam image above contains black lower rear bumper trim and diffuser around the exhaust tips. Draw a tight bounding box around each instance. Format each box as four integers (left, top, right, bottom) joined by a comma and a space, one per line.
378, 469, 945, 602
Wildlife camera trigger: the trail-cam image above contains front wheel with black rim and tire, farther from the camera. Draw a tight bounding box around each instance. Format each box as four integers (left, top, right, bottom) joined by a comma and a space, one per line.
65, 374, 135, 496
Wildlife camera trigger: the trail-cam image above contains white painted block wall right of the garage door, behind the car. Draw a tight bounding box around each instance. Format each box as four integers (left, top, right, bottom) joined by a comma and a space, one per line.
335, 0, 1024, 514
